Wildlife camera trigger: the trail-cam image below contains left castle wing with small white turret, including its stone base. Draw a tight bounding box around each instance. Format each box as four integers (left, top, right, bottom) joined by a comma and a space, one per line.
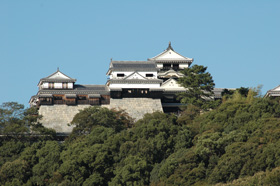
29, 69, 110, 133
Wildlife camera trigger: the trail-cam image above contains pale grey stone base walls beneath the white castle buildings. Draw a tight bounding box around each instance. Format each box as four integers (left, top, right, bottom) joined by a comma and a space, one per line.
39, 98, 163, 133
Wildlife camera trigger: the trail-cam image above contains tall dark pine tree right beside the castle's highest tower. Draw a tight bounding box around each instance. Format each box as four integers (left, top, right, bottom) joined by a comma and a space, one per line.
178, 65, 215, 110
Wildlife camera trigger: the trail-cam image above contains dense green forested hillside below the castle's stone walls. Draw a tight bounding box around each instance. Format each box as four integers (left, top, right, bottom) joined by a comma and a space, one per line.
0, 90, 280, 186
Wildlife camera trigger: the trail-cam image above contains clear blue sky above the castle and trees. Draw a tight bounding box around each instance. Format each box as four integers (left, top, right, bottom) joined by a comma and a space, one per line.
0, 0, 280, 106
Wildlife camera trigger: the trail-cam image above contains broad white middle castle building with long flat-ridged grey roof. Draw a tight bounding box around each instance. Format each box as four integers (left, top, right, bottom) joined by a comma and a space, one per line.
106, 61, 162, 98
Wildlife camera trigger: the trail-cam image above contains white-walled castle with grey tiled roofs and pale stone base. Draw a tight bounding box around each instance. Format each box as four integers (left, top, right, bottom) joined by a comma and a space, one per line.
29, 43, 223, 133
